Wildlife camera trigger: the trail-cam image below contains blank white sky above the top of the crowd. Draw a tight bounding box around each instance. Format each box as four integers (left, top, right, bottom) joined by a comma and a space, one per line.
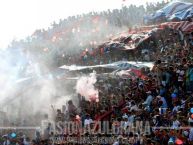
0, 0, 162, 48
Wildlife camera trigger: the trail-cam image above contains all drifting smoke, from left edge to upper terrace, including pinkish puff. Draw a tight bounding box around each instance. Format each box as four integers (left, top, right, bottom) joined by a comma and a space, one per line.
0, 10, 127, 124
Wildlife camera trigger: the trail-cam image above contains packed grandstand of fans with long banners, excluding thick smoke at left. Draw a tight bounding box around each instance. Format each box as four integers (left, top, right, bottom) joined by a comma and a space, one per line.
0, 1, 193, 145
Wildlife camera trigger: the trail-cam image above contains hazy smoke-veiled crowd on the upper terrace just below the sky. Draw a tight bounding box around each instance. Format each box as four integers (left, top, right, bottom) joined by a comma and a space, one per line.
9, 1, 169, 68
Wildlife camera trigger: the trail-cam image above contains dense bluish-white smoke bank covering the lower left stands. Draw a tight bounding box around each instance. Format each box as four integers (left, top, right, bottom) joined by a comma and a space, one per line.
0, 51, 75, 125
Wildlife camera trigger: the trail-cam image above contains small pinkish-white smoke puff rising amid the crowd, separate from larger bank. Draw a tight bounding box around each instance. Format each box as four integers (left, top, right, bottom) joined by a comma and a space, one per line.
76, 73, 99, 102
